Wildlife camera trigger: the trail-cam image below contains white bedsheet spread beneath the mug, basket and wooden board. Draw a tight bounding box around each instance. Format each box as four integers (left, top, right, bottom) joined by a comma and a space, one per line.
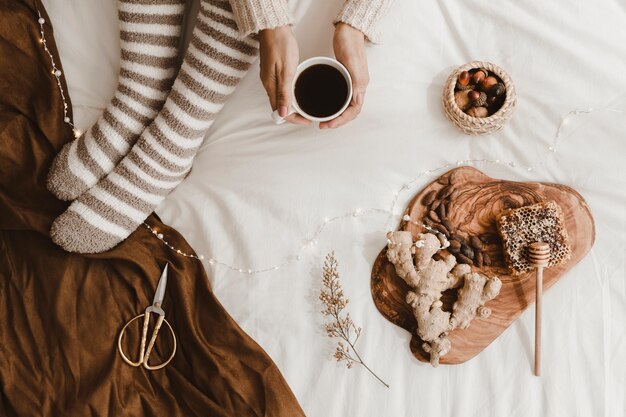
44, 0, 626, 417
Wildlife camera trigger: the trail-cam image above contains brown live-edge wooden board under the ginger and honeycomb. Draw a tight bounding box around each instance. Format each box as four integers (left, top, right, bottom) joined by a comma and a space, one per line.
371, 167, 595, 365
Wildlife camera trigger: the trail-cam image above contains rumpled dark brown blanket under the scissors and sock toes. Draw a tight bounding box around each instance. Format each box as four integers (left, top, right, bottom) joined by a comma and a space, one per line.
0, 0, 304, 417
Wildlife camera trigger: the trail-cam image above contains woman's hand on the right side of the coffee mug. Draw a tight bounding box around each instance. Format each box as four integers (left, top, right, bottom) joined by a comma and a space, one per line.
320, 22, 370, 129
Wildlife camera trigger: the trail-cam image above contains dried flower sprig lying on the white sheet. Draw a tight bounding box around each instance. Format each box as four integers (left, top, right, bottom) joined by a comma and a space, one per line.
319, 252, 389, 388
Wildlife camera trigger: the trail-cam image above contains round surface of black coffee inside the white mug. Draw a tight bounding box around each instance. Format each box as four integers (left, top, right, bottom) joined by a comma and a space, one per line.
295, 64, 348, 118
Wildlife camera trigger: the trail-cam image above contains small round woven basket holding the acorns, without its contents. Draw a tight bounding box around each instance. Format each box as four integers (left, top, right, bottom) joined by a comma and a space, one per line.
443, 61, 517, 135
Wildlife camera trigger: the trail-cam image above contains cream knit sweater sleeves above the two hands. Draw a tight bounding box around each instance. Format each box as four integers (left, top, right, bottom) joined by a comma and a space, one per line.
230, 0, 393, 43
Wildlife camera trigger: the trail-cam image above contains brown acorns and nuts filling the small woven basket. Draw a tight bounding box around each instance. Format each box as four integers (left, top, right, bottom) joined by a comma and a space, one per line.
454, 68, 506, 117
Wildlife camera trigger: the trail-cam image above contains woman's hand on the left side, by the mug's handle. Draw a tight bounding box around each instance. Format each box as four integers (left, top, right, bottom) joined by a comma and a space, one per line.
259, 26, 311, 125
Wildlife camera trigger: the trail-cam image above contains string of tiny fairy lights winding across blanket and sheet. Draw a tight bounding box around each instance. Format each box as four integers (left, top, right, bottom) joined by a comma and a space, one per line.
37, 10, 624, 275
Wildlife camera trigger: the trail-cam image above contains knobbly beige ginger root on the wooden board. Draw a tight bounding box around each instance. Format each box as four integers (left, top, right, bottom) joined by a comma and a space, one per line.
387, 231, 502, 366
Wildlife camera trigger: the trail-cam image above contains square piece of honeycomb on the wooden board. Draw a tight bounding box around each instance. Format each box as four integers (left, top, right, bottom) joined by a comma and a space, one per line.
497, 201, 571, 275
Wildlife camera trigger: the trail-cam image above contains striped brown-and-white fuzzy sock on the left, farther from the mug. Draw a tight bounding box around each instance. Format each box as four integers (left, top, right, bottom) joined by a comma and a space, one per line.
48, 0, 185, 200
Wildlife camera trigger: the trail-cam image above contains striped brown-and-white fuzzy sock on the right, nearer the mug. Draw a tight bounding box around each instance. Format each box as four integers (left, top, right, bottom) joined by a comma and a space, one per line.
51, 0, 258, 253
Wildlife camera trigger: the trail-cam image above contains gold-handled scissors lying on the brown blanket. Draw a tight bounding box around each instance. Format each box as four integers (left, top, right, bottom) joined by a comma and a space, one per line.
117, 264, 176, 371
